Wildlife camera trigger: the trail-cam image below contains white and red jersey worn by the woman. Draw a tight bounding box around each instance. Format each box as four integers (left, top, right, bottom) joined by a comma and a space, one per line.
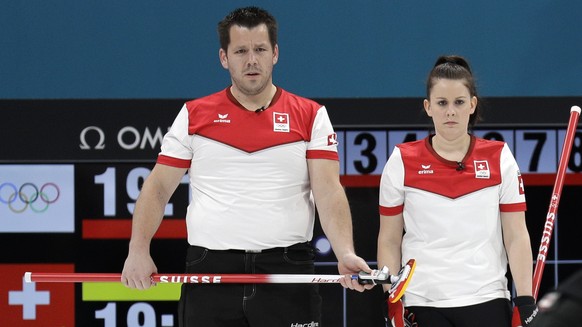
380, 136, 526, 307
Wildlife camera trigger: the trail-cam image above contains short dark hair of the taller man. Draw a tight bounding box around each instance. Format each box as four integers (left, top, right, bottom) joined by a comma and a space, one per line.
218, 7, 277, 51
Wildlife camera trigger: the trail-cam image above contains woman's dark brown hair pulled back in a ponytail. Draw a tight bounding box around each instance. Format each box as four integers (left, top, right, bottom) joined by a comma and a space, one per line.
426, 55, 481, 130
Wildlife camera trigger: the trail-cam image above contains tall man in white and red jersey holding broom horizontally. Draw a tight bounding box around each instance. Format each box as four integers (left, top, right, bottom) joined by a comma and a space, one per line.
122, 7, 371, 327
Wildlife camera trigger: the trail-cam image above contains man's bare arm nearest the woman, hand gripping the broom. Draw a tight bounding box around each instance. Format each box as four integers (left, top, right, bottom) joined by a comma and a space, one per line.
307, 159, 372, 291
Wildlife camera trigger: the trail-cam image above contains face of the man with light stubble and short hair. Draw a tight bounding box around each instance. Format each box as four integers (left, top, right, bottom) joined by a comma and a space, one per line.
219, 24, 279, 96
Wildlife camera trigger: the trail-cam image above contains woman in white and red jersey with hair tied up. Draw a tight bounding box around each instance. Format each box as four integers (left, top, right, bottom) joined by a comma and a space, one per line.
378, 56, 537, 327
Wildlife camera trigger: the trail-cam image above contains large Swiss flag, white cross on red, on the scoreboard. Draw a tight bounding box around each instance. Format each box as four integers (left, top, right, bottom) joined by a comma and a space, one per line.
0, 264, 75, 327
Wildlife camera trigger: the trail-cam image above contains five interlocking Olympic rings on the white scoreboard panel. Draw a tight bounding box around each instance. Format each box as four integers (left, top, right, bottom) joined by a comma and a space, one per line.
0, 183, 61, 213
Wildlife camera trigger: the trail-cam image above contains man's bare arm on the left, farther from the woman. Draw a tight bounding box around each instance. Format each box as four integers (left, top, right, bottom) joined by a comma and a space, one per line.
121, 164, 187, 289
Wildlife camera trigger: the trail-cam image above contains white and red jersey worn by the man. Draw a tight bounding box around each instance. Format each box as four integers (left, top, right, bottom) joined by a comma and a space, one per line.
157, 88, 339, 250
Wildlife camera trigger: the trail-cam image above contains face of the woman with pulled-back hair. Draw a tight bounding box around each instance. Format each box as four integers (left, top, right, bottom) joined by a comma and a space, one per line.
424, 78, 477, 140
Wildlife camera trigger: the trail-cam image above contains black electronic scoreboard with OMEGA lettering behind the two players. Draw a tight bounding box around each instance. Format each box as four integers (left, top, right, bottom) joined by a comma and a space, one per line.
0, 98, 582, 327
